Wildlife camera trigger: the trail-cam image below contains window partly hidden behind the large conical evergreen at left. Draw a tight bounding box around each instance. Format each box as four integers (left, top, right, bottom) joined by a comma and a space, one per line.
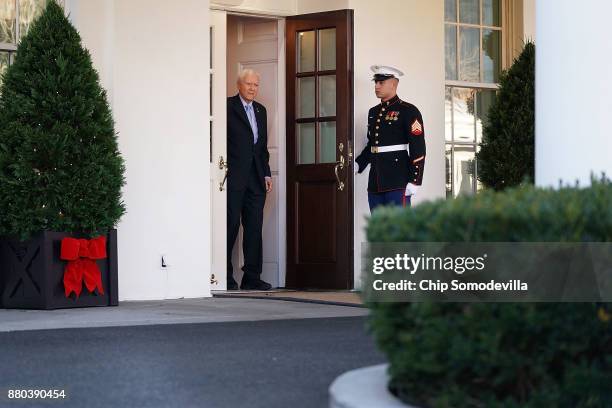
0, 0, 53, 89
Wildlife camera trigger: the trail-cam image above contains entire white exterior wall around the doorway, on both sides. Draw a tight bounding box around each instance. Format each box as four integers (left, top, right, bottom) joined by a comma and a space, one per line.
67, 0, 454, 300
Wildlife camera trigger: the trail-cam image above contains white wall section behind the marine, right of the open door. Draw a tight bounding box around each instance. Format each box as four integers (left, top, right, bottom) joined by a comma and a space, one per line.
349, 0, 446, 287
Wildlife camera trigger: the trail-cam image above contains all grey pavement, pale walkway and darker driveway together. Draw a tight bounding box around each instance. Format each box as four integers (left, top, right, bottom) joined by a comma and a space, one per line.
0, 299, 384, 408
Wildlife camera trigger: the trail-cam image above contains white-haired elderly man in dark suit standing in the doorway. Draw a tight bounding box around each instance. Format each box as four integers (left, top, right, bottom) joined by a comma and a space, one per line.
227, 69, 272, 290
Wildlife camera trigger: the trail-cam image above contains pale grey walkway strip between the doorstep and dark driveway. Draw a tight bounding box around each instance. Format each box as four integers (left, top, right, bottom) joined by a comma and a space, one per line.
0, 298, 367, 332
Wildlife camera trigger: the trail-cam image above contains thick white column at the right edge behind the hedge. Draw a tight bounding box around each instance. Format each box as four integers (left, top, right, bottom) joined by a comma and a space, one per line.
535, 0, 612, 186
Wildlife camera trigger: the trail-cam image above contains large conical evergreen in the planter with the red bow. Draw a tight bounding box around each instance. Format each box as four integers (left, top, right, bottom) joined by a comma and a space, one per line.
0, 1, 125, 239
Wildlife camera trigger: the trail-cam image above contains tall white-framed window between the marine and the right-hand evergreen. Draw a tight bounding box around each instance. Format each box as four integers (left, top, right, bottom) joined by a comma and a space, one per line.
444, 0, 505, 197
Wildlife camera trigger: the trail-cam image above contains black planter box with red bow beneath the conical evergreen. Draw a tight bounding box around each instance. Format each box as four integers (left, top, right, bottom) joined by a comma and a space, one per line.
0, 230, 119, 310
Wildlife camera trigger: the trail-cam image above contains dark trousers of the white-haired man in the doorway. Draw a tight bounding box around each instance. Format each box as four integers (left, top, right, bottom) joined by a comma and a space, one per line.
227, 165, 266, 281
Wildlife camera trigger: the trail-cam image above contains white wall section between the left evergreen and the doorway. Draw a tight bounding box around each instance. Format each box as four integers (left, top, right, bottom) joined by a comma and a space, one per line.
67, 0, 210, 300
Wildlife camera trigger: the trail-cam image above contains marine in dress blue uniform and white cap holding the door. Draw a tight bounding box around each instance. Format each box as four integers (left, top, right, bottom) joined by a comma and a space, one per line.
355, 65, 425, 211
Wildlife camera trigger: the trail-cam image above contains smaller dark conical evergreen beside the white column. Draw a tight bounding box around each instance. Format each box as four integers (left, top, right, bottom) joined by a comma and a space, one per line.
476, 42, 535, 190
